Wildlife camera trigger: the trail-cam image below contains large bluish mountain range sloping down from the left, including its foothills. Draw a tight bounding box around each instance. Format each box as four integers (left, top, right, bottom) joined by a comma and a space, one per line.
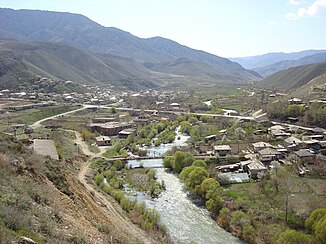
0, 9, 261, 89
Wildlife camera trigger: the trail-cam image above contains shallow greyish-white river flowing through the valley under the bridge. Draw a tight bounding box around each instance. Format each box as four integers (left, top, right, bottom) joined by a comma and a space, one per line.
128, 130, 244, 244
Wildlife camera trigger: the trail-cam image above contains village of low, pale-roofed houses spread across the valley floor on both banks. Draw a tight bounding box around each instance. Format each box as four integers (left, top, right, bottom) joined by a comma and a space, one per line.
0, 78, 326, 186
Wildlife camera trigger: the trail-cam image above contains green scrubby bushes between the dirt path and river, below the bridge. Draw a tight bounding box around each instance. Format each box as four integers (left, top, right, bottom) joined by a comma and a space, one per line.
94, 160, 171, 243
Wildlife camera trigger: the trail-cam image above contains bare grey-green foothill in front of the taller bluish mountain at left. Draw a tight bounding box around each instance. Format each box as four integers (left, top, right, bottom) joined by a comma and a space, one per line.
0, 41, 168, 89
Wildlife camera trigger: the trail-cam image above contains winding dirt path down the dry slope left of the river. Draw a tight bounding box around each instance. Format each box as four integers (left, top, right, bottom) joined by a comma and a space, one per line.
75, 131, 155, 243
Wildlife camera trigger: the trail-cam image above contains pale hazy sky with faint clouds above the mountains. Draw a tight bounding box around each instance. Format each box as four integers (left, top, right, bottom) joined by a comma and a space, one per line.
0, 0, 326, 57
